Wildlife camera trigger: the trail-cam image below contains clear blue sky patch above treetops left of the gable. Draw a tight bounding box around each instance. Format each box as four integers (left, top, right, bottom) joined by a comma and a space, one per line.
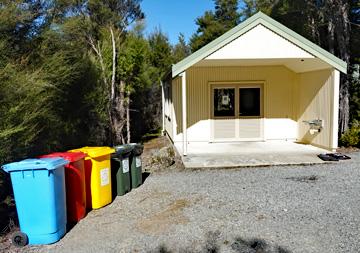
141, 0, 214, 44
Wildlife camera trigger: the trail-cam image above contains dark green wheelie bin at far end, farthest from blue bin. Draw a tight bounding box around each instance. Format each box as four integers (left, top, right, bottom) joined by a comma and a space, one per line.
127, 143, 144, 188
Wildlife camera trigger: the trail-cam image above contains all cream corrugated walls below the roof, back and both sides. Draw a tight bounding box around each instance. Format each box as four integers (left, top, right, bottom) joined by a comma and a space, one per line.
166, 66, 333, 148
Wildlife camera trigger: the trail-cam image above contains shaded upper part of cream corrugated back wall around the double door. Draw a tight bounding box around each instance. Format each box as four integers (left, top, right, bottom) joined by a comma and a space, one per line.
187, 66, 295, 120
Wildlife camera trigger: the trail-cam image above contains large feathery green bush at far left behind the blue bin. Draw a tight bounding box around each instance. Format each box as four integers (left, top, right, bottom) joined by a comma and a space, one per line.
0, 1, 109, 163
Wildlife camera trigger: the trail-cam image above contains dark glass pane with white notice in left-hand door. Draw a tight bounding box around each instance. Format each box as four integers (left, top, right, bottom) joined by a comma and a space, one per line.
214, 88, 235, 117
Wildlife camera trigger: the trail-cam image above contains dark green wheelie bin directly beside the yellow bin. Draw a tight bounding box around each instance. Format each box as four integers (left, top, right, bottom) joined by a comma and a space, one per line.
111, 145, 133, 199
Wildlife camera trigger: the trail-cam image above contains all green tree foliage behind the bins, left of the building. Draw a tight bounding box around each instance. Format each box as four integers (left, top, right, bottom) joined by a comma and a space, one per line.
0, 0, 176, 164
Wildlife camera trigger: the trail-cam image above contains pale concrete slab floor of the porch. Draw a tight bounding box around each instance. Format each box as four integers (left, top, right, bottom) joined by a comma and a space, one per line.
175, 141, 329, 169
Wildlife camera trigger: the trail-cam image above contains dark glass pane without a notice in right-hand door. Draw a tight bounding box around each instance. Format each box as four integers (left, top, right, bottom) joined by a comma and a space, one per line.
239, 88, 260, 116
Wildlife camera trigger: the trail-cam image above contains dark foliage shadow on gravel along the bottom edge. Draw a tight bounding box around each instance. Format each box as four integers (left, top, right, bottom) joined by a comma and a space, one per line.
148, 231, 291, 253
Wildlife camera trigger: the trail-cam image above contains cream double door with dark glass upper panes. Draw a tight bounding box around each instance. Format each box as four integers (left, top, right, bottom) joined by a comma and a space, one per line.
211, 83, 264, 142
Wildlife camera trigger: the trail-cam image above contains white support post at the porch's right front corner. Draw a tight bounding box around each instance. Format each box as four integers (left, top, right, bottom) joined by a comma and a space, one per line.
330, 69, 340, 151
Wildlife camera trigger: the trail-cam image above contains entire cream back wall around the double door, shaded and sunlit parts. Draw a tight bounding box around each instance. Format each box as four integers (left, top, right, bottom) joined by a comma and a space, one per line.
187, 66, 297, 141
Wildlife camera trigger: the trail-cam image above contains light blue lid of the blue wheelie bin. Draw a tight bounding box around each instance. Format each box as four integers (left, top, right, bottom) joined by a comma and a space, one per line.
1, 157, 69, 173
